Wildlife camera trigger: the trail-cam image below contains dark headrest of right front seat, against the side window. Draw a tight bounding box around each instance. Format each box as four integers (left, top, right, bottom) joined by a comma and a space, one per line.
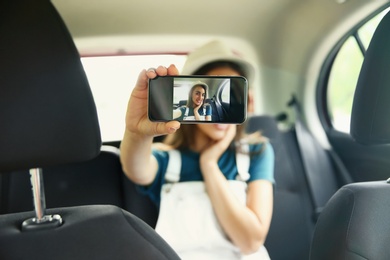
351, 9, 390, 145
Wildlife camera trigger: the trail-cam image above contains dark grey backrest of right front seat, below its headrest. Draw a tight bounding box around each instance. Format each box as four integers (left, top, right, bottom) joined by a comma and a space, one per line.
310, 181, 390, 260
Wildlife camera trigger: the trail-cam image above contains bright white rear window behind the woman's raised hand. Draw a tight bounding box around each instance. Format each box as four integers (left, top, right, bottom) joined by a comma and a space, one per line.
81, 55, 186, 142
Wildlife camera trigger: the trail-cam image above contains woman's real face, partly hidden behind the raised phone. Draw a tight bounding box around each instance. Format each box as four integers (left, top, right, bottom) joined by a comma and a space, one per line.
196, 67, 240, 141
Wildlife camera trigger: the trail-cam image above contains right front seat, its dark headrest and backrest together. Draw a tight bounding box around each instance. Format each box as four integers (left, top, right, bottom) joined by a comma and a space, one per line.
310, 8, 390, 260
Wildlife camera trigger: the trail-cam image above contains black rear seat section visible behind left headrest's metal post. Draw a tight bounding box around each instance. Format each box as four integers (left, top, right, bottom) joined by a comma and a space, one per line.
0, 145, 125, 214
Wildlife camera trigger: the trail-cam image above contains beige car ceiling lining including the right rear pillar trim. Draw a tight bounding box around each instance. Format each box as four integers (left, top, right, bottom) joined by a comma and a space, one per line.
53, 0, 389, 136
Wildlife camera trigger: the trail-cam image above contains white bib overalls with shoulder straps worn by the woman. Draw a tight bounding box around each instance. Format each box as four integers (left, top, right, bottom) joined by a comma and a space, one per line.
156, 147, 270, 260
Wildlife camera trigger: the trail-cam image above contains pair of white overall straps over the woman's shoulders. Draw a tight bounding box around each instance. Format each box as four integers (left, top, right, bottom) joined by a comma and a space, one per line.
165, 144, 250, 183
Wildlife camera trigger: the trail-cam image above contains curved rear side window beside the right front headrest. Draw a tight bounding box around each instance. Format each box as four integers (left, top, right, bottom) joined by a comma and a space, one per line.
326, 8, 390, 133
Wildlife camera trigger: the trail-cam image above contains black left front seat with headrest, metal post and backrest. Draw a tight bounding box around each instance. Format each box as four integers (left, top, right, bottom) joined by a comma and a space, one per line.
0, 0, 179, 259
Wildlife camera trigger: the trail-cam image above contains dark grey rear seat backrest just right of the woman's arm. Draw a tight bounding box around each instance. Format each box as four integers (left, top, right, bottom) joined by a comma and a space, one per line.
247, 116, 314, 260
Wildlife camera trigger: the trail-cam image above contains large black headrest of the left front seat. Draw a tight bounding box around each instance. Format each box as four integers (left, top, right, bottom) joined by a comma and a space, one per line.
0, 0, 101, 172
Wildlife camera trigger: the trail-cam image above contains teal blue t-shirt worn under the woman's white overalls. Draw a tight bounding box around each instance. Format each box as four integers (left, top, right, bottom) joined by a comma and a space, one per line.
138, 143, 275, 206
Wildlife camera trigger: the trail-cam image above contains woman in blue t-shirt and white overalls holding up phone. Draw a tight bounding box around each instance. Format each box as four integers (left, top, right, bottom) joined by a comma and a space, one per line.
121, 39, 274, 259
